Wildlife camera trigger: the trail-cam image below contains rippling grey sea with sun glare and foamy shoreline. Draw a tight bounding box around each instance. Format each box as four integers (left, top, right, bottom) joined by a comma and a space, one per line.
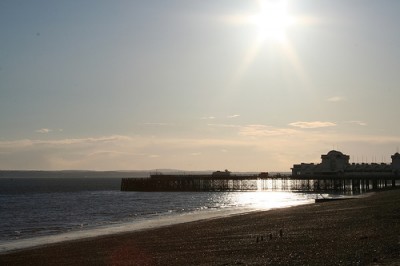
0, 173, 316, 253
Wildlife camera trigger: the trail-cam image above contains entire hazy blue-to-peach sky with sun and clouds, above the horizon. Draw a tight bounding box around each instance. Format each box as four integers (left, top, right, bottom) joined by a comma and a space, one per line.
0, 0, 400, 171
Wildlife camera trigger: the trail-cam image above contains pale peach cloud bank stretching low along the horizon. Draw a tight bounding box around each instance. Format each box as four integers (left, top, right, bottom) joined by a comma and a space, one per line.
0, 122, 400, 171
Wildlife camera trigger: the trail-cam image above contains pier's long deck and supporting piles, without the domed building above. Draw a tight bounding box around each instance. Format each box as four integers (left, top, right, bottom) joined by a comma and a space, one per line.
121, 174, 400, 192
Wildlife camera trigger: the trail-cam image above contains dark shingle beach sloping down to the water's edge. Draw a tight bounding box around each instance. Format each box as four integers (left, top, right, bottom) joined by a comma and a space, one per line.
0, 190, 400, 265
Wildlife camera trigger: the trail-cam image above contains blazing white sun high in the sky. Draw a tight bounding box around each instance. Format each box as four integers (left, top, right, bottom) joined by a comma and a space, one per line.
249, 0, 294, 42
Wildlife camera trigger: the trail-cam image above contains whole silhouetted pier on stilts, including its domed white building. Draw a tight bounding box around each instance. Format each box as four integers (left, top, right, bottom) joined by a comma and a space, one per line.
121, 150, 400, 193
